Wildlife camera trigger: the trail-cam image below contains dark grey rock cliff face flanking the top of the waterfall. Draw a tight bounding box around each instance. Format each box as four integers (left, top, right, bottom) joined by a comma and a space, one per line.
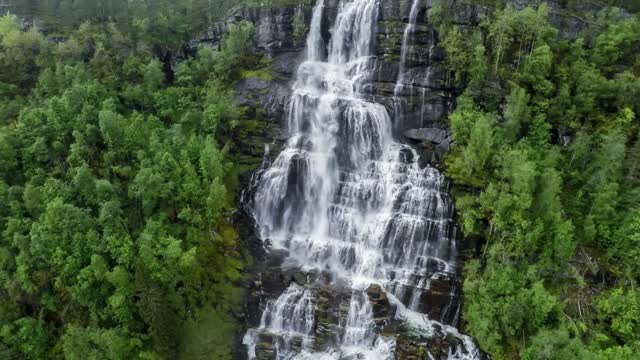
190, 0, 479, 166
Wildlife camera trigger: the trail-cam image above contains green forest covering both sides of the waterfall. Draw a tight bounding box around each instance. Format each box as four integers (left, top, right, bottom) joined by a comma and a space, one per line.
0, 0, 640, 360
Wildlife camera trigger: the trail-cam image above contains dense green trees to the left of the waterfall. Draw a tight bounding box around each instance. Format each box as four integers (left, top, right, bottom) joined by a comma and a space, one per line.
0, 1, 268, 359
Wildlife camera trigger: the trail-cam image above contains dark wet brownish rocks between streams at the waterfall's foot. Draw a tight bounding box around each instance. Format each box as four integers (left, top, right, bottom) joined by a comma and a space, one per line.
246, 251, 482, 360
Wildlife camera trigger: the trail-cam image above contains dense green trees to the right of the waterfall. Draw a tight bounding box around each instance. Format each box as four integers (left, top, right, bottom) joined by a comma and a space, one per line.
431, 1, 640, 360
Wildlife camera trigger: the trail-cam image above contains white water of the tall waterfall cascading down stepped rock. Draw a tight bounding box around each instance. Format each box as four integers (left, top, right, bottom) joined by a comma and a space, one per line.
243, 0, 477, 360
